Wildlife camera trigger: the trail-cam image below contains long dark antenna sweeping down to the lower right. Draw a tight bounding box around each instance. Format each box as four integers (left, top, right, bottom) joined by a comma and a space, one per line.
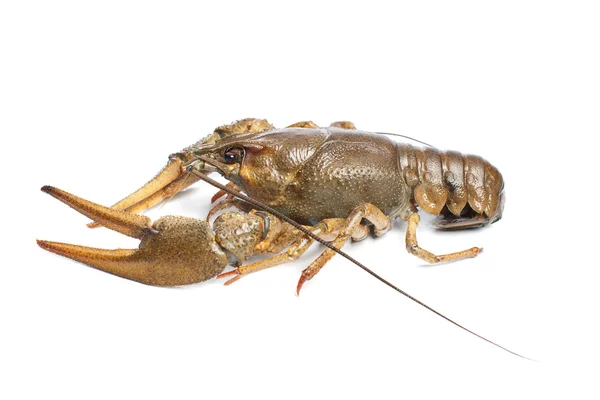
188, 169, 531, 360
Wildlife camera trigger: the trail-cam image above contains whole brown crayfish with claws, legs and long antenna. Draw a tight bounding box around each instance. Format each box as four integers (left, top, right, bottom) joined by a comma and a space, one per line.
38, 119, 524, 353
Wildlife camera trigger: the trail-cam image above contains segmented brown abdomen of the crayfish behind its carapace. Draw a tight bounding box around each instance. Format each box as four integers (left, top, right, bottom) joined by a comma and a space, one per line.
398, 144, 504, 217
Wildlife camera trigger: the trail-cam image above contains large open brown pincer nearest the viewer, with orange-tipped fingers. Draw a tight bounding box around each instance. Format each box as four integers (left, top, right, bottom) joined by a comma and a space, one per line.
38, 186, 228, 286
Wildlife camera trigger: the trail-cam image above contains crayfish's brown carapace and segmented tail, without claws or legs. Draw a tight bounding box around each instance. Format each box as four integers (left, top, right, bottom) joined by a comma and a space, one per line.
199, 127, 504, 229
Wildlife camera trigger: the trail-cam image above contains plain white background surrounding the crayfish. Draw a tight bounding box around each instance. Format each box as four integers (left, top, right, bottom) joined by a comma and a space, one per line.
0, 0, 600, 399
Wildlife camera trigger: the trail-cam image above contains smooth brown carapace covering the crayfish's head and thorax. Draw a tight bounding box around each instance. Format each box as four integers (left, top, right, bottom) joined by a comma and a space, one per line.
208, 127, 410, 225
